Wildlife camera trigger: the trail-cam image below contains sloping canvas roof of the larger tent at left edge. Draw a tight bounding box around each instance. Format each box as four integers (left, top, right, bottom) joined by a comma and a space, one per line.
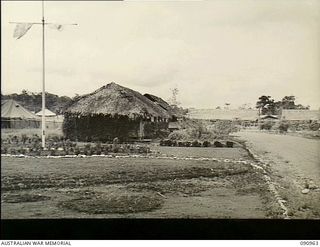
1, 99, 39, 119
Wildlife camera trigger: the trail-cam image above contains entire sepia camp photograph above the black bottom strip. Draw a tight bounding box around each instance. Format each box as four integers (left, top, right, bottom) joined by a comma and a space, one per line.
1, 0, 320, 239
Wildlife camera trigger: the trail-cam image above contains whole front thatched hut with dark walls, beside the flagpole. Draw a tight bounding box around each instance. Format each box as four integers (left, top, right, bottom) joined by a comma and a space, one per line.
63, 82, 172, 141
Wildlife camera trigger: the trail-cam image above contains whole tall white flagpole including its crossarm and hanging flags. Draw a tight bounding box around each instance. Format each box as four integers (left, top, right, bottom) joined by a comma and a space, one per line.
9, 0, 78, 149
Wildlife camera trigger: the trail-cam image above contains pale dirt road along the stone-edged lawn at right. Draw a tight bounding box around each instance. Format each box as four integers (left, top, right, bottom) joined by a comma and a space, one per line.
235, 131, 320, 218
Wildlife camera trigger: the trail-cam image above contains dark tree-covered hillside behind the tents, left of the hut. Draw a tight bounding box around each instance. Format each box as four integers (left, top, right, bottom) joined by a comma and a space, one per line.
1, 90, 72, 114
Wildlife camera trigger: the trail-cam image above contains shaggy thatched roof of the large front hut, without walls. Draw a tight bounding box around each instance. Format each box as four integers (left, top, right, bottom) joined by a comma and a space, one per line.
65, 82, 171, 118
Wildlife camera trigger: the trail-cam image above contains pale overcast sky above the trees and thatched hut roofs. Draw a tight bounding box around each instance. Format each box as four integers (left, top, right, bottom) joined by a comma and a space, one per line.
1, 0, 320, 109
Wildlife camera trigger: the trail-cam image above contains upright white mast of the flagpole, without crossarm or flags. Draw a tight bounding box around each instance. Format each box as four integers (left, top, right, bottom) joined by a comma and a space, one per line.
41, 0, 46, 149
